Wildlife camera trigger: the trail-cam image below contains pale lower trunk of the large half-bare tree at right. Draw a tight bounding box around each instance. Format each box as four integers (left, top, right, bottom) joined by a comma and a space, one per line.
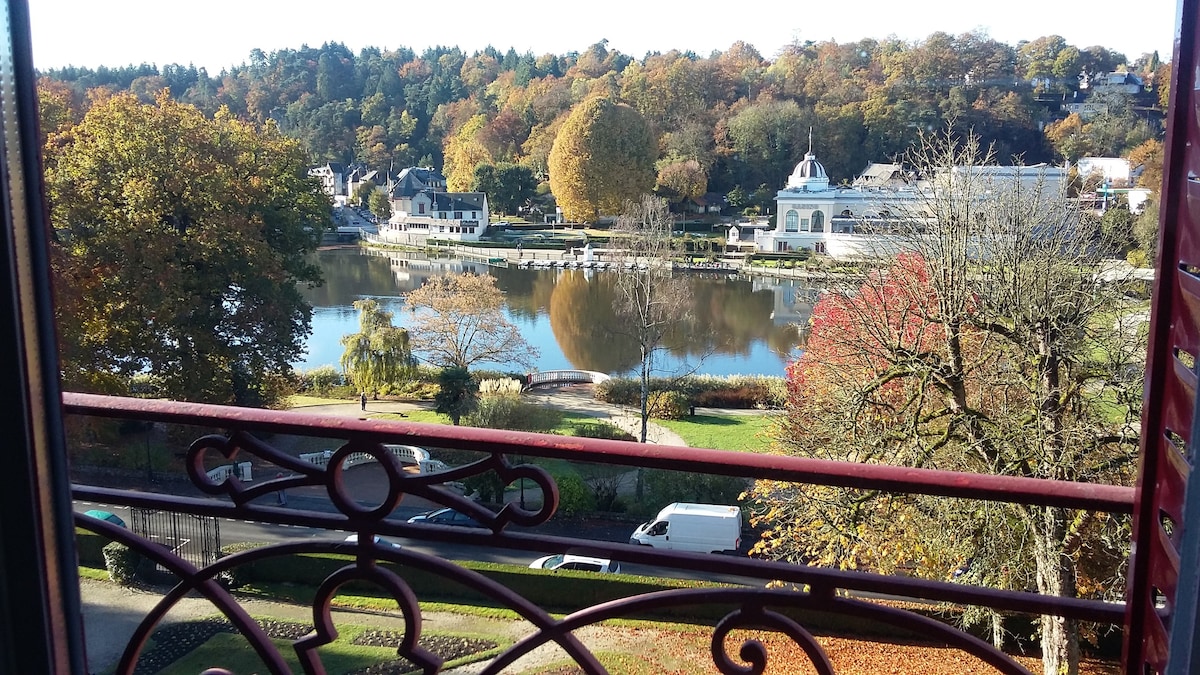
1034, 508, 1079, 675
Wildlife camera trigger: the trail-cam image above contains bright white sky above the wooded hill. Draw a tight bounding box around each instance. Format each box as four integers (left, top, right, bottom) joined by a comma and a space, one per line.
29, 0, 1175, 74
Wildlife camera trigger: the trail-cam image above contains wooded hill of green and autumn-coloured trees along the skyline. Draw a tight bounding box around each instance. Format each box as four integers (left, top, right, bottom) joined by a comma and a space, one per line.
42, 32, 1170, 193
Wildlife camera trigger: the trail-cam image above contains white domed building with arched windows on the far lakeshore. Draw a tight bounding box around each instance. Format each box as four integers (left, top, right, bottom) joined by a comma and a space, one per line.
727, 145, 1067, 259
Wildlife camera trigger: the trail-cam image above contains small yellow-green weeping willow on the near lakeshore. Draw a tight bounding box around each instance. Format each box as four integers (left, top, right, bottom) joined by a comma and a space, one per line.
342, 299, 416, 398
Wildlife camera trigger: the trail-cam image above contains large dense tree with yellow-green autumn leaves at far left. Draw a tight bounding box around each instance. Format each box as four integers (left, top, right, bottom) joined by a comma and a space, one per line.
46, 92, 331, 405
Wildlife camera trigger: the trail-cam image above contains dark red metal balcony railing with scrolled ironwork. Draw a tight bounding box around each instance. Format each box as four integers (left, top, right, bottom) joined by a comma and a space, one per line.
64, 394, 1134, 674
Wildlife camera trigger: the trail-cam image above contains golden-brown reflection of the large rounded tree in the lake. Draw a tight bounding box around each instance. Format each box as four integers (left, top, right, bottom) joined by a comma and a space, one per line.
550, 271, 641, 372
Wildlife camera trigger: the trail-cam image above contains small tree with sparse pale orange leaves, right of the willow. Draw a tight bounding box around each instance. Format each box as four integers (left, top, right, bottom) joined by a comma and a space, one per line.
404, 274, 538, 369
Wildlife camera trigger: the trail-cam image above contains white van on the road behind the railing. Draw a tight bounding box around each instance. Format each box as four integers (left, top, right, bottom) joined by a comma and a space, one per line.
629, 503, 742, 554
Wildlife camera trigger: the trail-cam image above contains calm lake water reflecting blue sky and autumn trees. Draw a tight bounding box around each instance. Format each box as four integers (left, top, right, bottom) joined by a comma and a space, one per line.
296, 247, 817, 376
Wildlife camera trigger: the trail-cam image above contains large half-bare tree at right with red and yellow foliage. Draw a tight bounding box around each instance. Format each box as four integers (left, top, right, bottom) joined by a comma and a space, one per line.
752, 132, 1145, 673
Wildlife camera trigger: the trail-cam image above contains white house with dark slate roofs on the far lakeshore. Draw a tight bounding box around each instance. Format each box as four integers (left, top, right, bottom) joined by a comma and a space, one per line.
379, 167, 488, 246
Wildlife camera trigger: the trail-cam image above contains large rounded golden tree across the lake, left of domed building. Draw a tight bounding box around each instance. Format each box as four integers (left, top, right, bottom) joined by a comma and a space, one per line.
550, 96, 658, 222
